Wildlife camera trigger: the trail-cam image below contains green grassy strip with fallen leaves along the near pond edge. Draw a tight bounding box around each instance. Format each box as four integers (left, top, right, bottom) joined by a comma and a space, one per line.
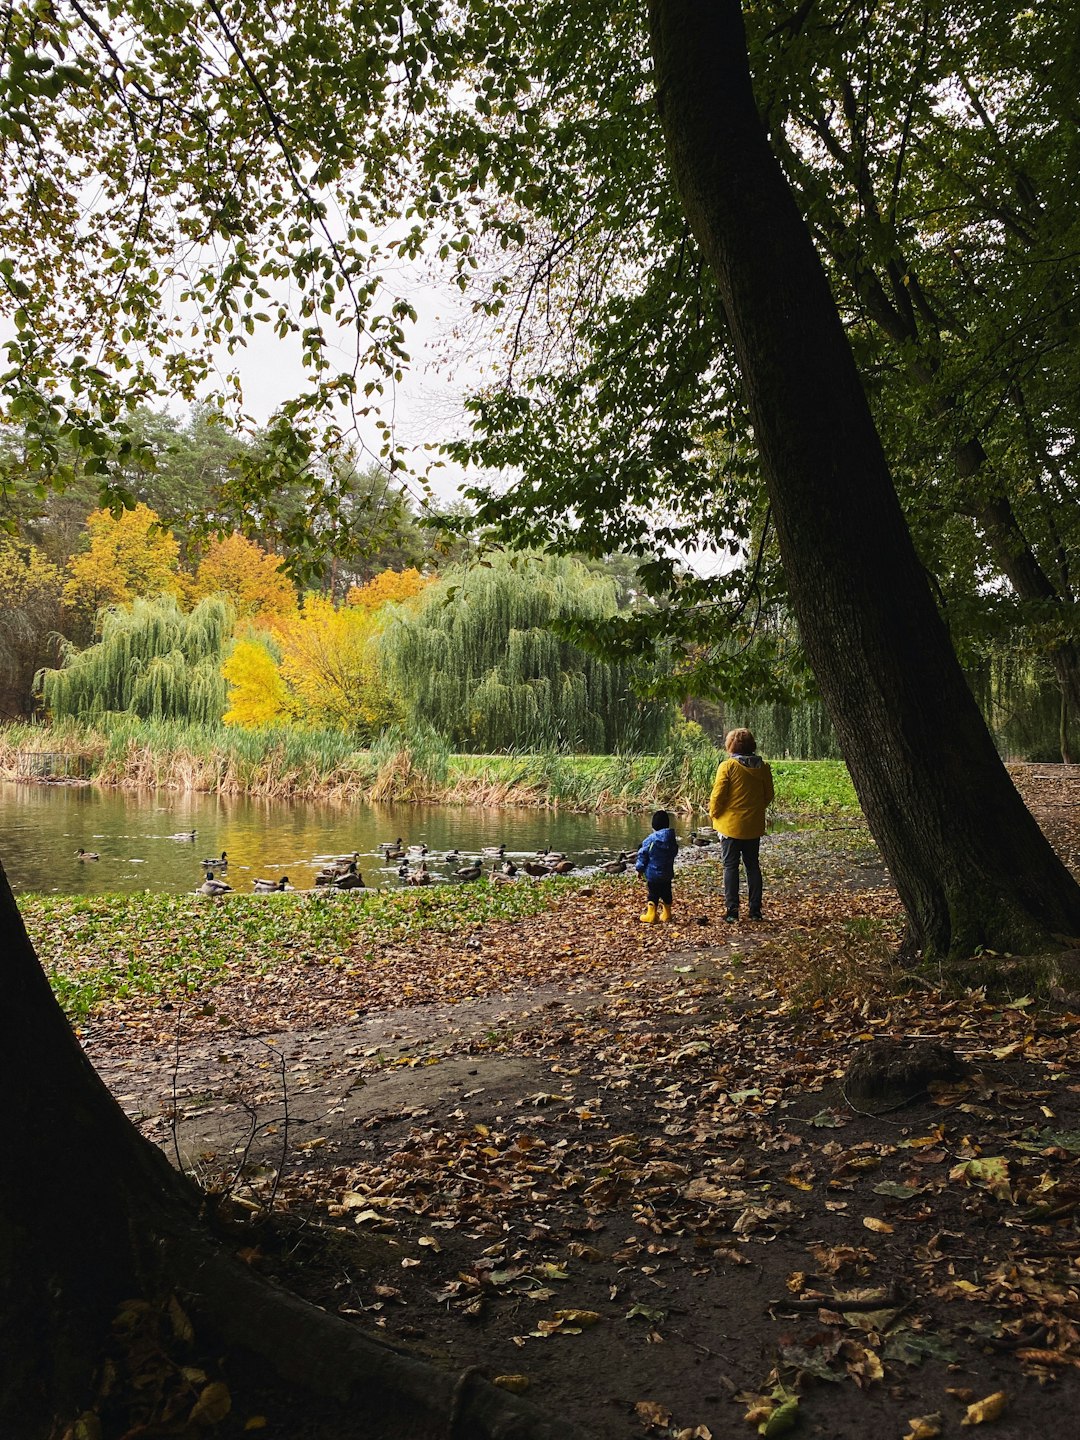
20, 886, 567, 1025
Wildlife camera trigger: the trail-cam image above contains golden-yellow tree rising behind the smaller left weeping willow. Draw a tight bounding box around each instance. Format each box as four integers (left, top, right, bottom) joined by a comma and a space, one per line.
63, 504, 183, 618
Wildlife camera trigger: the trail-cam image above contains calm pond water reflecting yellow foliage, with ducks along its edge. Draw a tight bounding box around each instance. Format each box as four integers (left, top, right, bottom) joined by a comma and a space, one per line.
0, 783, 676, 894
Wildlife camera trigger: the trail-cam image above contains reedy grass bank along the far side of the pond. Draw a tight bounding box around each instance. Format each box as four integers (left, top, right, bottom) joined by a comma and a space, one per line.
0, 716, 855, 814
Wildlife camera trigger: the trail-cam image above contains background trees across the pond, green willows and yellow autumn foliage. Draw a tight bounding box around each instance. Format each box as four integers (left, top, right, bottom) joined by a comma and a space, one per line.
0, 409, 1058, 759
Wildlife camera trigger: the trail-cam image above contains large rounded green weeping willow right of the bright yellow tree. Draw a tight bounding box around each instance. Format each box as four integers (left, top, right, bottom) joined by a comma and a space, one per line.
383, 556, 671, 753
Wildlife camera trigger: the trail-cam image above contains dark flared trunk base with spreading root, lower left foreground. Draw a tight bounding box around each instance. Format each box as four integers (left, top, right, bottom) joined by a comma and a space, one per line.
0, 868, 582, 1440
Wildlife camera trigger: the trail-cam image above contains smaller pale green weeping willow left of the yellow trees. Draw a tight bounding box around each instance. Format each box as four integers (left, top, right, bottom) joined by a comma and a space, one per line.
40, 595, 235, 724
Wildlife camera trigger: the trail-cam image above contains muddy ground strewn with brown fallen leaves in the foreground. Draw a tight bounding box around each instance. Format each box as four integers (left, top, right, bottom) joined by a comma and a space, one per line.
84, 772, 1080, 1440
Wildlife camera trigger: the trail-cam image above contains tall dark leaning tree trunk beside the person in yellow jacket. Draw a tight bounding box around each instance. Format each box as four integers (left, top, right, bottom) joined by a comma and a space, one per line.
649, 0, 1080, 956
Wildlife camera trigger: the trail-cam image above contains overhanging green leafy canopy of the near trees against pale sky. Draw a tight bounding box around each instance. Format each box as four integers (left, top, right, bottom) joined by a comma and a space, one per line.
0, 0, 1080, 731
